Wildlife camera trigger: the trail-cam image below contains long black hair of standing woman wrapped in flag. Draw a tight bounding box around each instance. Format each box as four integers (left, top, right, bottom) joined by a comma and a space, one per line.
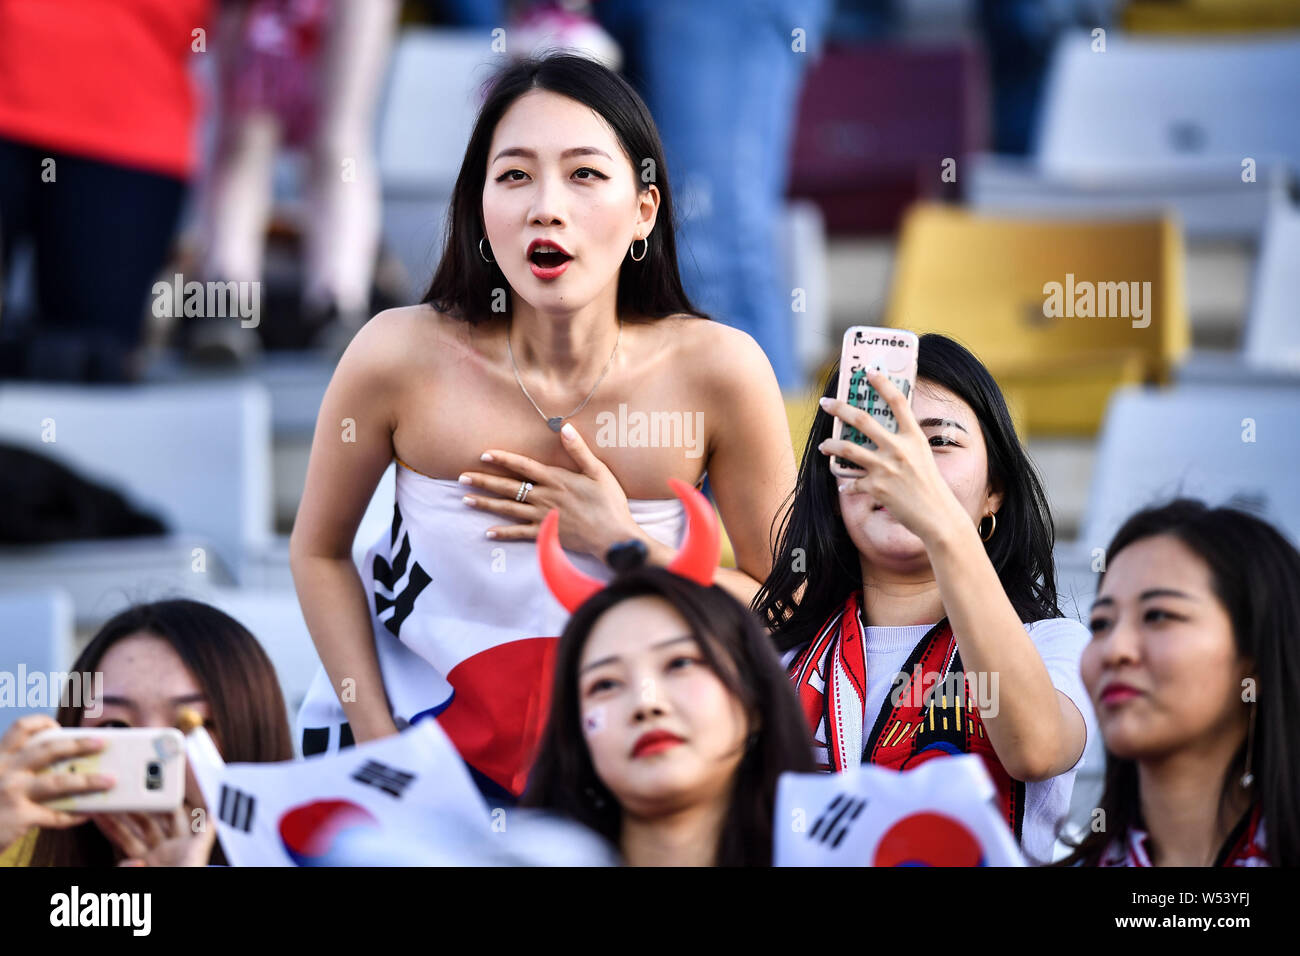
424, 53, 707, 324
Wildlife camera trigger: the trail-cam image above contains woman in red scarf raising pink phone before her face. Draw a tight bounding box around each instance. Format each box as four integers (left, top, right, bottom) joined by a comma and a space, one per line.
755, 334, 1092, 862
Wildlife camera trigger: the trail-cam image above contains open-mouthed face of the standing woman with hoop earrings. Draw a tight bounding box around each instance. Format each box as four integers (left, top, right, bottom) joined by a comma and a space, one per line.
482, 90, 659, 312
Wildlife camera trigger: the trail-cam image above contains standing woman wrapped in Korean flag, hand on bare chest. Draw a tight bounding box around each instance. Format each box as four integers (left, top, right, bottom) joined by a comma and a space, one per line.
291, 56, 794, 803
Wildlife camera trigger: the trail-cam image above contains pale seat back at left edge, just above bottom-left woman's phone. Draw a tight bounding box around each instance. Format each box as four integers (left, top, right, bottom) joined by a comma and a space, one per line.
0, 581, 73, 736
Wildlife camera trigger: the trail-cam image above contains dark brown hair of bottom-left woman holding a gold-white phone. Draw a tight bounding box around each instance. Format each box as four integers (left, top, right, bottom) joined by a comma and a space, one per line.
31, 600, 294, 866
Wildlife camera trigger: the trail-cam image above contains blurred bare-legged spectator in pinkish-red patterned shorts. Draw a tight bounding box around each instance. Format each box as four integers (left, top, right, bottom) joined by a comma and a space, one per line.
186, 0, 398, 359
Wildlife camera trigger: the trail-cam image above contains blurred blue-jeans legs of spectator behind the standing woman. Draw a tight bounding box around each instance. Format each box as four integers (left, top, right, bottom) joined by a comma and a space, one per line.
594, 0, 831, 388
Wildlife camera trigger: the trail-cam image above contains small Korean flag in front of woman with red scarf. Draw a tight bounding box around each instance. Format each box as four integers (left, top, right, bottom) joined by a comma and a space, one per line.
772, 754, 1024, 866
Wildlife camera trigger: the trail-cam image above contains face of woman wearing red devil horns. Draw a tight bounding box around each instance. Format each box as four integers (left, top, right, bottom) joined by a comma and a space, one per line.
579, 594, 749, 817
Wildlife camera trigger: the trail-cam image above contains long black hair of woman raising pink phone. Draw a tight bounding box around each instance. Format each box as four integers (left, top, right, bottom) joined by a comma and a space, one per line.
753, 333, 1061, 650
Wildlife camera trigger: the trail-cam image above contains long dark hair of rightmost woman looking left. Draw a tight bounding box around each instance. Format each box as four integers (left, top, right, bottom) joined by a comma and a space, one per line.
1061, 498, 1300, 866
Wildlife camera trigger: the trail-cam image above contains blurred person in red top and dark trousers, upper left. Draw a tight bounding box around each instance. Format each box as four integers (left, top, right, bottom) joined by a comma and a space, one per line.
0, 0, 216, 381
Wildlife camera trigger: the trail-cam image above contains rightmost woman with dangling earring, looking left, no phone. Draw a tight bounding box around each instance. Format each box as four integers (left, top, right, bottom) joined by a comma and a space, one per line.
1063, 499, 1300, 866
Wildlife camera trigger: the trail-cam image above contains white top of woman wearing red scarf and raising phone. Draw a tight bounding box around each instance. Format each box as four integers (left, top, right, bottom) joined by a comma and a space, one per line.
783, 618, 1097, 864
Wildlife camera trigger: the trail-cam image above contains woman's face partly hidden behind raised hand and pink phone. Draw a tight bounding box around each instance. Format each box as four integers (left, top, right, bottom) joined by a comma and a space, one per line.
840, 378, 1002, 571
